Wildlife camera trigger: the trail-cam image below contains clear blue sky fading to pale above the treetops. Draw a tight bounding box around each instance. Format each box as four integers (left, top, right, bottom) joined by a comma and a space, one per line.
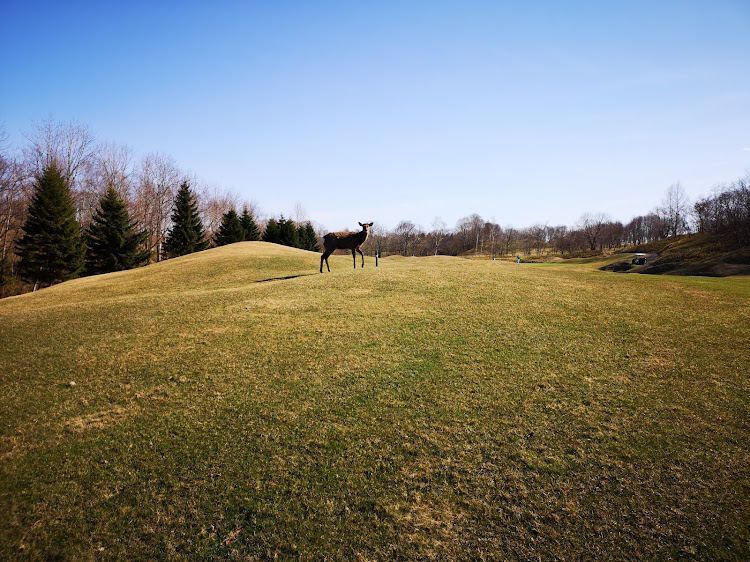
0, 0, 750, 230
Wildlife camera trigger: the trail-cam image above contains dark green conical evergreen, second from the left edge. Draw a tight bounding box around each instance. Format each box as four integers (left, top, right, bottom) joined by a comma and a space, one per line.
86, 187, 151, 273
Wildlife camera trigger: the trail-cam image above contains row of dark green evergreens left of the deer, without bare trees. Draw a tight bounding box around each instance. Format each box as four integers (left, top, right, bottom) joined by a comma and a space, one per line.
3, 162, 319, 291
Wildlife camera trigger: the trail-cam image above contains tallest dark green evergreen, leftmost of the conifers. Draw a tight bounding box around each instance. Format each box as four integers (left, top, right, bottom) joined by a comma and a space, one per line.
16, 164, 86, 289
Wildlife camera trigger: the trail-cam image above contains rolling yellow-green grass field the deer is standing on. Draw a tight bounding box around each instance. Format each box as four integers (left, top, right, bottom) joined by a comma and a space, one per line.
0, 243, 750, 560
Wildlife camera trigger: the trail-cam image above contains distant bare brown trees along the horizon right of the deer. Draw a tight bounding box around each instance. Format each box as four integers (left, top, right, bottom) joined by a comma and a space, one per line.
370, 174, 750, 257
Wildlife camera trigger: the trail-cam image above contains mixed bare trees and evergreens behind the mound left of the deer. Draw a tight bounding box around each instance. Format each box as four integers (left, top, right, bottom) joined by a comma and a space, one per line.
0, 119, 319, 296
